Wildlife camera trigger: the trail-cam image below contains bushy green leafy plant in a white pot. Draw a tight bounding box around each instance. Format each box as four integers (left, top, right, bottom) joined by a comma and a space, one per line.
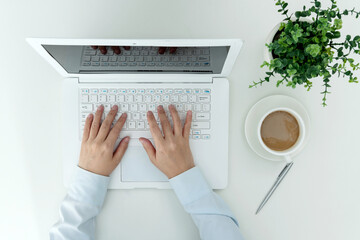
249, 0, 360, 106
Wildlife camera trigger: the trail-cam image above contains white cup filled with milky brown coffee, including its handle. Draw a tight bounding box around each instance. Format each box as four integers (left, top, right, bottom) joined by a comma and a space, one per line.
258, 108, 305, 162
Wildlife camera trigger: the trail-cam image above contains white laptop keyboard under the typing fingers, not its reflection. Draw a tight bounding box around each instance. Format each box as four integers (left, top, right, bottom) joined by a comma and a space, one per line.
80, 88, 211, 140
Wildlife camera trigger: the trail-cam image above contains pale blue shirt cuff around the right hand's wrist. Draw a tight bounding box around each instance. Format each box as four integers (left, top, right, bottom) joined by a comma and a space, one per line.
169, 167, 212, 205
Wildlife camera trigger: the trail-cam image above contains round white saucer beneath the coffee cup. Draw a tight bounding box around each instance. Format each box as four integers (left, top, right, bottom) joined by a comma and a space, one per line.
245, 95, 310, 161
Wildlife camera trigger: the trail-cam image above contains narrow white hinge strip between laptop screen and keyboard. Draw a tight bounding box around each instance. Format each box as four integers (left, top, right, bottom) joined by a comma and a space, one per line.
79, 74, 213, 83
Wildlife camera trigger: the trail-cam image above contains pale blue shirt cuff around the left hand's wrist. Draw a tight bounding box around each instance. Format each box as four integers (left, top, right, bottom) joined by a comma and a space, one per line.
70, 167, 110, 207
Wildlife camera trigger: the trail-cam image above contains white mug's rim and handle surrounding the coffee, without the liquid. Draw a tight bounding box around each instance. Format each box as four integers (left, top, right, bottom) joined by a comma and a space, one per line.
258, 107, 305, 162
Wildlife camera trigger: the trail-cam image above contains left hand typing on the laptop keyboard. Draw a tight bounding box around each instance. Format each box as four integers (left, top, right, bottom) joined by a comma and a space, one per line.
79, 105, 130, 176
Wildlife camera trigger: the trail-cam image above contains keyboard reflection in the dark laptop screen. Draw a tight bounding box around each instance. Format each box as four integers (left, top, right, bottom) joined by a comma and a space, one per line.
81, 46, 210, 67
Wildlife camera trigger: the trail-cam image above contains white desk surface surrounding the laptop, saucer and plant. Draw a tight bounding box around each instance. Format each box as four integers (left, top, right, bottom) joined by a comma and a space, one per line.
0, 0, 360, 240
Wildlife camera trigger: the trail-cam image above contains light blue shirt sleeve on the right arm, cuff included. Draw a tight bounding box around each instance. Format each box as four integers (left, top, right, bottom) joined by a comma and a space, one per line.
169, 167, 243, 240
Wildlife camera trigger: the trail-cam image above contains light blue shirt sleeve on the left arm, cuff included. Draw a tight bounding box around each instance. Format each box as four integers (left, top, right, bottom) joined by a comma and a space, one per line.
50, 167, 110, 240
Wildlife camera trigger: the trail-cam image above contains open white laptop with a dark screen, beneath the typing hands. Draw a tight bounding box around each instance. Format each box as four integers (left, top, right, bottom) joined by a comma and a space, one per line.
27, 38, 242, 189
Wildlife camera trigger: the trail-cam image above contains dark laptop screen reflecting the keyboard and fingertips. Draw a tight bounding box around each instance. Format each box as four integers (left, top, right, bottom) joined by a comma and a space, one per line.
42, 45, 230, 74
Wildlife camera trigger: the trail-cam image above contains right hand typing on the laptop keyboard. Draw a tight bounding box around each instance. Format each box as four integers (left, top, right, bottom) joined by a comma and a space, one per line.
139, 105, 195, 179
